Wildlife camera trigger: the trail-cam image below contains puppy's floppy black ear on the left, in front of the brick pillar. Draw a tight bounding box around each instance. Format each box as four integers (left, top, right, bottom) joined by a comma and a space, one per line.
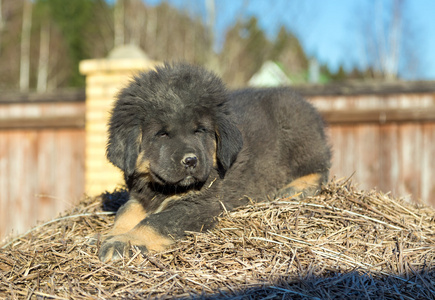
106, 102, 142, 176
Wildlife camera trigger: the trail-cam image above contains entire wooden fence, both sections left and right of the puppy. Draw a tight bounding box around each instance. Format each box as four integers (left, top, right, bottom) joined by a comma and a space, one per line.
0, 82, 435, 239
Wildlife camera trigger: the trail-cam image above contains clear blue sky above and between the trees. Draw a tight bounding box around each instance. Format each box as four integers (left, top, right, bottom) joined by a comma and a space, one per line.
144, 0, 435, 80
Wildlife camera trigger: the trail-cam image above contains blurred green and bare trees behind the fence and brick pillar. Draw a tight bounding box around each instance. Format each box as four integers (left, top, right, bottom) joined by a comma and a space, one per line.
0, 0, 410, 92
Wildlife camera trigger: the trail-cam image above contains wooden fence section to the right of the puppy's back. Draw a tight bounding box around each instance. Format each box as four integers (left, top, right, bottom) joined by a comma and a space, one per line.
298, 82, 435, 206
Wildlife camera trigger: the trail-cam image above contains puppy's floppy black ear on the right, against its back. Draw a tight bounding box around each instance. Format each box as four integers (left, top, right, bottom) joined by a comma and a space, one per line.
216, 117, 243, 173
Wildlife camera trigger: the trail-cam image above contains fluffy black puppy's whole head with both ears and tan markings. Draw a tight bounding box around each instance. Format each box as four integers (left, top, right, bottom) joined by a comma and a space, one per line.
107, 64, 242, 186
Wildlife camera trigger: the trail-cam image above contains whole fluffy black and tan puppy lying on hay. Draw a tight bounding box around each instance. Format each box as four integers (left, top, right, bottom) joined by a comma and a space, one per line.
99, 63, 331, 261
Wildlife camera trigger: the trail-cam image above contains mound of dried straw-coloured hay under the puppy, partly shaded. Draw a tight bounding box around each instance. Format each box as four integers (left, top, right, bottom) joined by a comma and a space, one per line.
0, 182, 435, 299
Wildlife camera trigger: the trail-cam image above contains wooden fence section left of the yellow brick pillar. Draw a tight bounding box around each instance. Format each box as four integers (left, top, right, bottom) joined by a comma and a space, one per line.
0, 91, 85, 240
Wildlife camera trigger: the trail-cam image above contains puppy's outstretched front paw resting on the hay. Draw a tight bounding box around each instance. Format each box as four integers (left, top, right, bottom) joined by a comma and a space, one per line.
98, 234, 147, 262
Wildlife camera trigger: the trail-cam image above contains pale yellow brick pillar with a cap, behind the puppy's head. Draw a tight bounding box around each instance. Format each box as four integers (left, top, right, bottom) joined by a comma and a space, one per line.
80, 45, 157, 196
